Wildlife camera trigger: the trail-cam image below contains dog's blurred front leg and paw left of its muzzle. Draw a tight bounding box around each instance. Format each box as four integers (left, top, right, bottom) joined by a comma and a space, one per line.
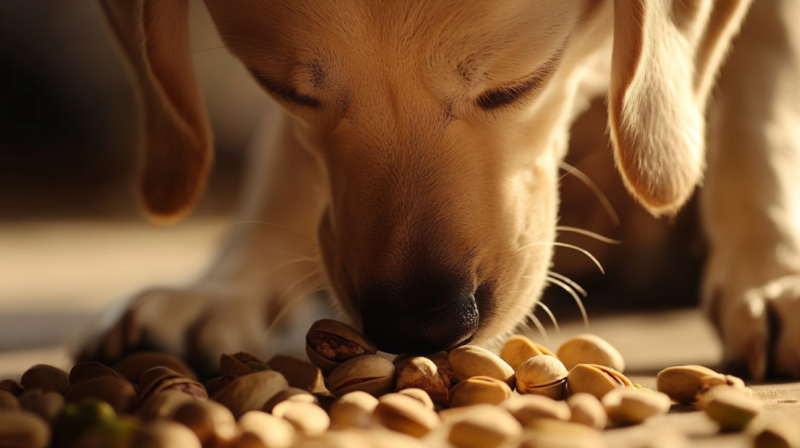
84, 112, 322, 372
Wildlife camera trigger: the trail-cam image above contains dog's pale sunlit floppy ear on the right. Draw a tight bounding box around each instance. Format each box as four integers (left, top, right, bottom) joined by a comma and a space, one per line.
608, 0, 751, 215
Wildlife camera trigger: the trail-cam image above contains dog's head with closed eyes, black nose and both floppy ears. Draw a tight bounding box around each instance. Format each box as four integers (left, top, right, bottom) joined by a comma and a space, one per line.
105, 0, 747, 352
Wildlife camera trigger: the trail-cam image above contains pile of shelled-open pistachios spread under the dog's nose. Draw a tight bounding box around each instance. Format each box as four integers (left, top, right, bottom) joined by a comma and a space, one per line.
0, 319, 794, 448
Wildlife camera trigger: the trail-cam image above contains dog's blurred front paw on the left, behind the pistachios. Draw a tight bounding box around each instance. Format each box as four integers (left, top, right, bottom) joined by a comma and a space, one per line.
78, 288, 265, 370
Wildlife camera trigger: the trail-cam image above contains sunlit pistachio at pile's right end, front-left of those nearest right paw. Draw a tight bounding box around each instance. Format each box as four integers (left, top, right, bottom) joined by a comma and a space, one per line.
602, 389, 672, 425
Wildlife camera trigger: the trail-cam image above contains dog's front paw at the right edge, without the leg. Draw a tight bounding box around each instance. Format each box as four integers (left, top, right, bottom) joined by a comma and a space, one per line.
704, 275, 800, 380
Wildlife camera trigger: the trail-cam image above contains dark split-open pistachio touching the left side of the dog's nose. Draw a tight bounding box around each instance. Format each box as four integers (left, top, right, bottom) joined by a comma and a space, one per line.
306, 319, 378, 375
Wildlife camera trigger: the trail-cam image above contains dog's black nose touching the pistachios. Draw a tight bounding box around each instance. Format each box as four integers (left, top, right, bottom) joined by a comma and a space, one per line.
361, 279, 478, 354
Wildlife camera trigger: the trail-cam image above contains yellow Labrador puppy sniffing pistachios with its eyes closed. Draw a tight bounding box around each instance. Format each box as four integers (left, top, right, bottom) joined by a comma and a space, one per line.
86, 0, 800, 379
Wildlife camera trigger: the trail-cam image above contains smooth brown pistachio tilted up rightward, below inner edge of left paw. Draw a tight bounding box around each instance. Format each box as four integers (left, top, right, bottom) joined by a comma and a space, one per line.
214, 370, 289, 418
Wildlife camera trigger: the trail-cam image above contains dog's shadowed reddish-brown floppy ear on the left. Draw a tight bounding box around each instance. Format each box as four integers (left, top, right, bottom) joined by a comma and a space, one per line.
101, 0, 213, 221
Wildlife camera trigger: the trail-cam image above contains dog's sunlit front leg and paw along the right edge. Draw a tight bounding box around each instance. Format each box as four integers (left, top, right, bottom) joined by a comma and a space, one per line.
702, 0, 800, 378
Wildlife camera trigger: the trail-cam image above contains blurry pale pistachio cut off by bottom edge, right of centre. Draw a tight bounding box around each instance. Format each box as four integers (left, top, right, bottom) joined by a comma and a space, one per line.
519, 419, 606, 448
